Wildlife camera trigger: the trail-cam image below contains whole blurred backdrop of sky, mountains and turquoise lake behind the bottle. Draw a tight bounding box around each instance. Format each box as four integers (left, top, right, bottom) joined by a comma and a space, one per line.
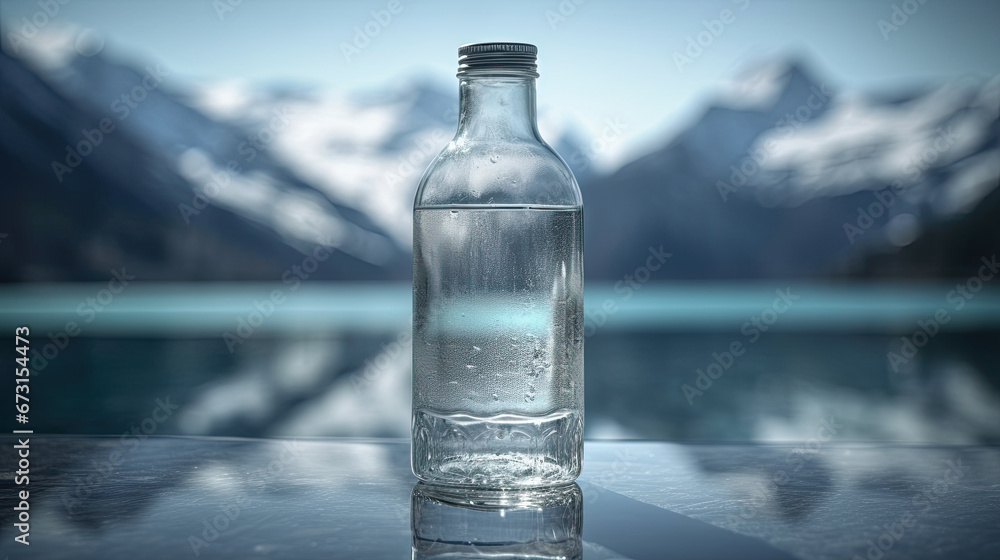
0, 0, 1000, 443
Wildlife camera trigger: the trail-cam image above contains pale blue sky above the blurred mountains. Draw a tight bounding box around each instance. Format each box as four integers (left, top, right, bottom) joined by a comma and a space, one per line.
0, 0, 1000, 164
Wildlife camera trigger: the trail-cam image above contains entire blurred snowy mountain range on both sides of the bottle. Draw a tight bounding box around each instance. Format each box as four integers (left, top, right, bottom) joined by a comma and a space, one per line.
0, 31, 1000, 281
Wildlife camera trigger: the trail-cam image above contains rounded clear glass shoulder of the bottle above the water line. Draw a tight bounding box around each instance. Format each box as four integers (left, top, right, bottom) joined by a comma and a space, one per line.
414, 137, 583, 208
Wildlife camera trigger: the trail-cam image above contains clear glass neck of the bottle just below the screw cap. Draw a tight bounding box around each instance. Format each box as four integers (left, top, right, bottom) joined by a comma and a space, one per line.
456, 77, 539, 141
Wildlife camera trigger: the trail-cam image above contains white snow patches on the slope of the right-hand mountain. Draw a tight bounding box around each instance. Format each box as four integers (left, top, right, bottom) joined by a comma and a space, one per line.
750, 78, 1000, 210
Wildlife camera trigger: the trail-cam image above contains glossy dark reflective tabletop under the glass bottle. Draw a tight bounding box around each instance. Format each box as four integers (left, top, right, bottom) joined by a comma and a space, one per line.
0, 436, 1000, 560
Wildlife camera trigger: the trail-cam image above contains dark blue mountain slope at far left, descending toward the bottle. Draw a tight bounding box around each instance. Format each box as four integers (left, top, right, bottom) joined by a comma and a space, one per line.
0, 30, 409, 280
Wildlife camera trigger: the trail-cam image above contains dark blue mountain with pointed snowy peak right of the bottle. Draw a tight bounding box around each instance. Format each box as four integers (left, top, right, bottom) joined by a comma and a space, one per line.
584, 60, 1000, 279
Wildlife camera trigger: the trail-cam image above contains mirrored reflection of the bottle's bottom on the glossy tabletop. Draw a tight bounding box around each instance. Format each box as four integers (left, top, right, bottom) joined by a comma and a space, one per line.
410, 482, 583, 560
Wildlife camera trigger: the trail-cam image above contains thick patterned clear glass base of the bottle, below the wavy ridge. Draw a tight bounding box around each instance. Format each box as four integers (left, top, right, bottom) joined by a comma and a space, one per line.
412, 404, 583, 488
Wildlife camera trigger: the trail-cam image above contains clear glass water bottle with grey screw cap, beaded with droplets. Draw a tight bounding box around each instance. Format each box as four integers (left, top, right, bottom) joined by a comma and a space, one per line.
411, 43, 583, 488
